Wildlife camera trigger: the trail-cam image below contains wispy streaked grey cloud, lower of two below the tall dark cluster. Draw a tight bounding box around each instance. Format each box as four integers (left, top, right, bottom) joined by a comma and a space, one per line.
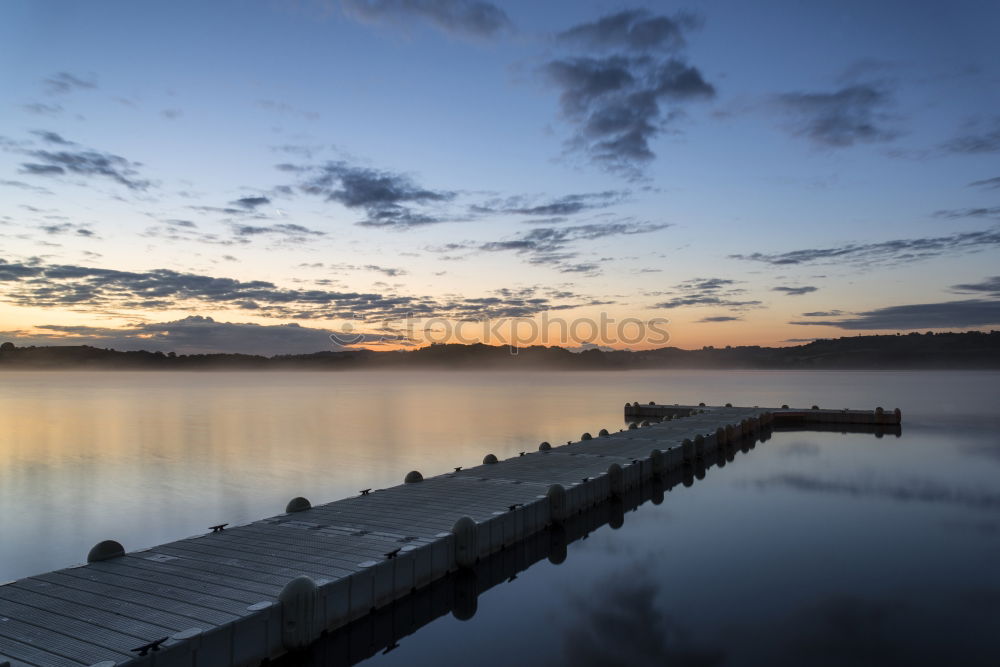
478, 222, 669, 274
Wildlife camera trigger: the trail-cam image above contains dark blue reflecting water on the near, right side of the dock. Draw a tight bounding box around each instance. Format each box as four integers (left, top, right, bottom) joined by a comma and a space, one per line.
365, 418, 1000, 666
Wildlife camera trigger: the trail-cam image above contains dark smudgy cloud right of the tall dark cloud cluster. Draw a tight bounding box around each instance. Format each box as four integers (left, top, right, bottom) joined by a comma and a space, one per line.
777, 84, 898, 147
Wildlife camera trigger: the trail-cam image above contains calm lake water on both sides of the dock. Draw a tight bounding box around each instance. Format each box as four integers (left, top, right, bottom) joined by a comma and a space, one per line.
0, 371, 1000, 666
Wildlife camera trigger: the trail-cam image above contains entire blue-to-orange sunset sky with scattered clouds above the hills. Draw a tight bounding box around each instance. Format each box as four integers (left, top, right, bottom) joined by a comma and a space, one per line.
0, 0, 1000, 354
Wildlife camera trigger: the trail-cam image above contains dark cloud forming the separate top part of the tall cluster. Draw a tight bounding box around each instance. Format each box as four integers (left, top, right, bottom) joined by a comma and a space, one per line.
556, 9, 699, 52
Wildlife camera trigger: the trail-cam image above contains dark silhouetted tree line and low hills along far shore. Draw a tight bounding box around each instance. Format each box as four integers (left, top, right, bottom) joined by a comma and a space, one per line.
0, 331, 1000, 370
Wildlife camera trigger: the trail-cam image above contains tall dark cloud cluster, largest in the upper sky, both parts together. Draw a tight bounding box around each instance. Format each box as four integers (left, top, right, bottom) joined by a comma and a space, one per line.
541, 9, 715, 179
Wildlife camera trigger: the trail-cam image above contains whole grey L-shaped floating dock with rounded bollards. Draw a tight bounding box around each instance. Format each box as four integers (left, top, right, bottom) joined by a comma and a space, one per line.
0, 403, 900, 667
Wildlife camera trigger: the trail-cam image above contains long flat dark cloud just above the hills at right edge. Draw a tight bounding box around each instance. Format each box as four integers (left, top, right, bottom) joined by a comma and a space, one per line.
789, 299, 1000, 330
